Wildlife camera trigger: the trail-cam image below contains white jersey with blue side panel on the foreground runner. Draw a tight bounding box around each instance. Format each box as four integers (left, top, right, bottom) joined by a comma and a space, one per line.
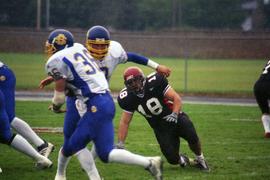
45, 43, 108, 97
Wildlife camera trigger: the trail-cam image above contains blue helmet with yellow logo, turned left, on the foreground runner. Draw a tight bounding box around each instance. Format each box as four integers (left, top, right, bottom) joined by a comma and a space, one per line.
45, 29, 74, 57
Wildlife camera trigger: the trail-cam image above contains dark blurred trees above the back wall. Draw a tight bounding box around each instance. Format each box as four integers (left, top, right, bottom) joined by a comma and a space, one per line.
0, 0, 270, 31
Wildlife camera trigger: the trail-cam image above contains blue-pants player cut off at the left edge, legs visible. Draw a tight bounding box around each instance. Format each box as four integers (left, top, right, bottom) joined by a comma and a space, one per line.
0, 61, 53, 168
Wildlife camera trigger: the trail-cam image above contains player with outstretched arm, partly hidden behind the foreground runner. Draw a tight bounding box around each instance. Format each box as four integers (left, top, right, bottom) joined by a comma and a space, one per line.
40, 26, 171, 176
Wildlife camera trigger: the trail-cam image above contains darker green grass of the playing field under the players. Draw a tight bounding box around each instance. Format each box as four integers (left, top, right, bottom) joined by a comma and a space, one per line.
0, 101, 270, 180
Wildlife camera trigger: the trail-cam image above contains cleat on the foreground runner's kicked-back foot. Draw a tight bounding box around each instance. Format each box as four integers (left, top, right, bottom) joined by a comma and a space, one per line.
146, 156, 163, 180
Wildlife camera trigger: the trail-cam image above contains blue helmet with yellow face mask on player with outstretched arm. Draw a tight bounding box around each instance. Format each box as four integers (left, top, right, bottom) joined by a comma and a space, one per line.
86, 26, 110, 60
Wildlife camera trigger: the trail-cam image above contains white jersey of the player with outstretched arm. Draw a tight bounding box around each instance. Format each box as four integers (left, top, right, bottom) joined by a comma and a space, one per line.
96, 41, 128, 81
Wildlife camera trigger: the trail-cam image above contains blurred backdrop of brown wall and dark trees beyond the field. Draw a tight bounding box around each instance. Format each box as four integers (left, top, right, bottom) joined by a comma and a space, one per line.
0, 0, 270, 58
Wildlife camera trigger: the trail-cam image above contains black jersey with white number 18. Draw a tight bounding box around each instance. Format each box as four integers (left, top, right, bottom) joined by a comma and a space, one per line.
117, 73, 175, 129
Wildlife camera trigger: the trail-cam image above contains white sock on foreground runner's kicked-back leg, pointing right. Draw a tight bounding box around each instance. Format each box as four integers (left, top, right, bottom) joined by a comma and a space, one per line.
109, 149, 151, 168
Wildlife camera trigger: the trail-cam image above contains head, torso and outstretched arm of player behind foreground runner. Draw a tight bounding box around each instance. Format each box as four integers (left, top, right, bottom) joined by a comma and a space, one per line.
82, 25, 171, 157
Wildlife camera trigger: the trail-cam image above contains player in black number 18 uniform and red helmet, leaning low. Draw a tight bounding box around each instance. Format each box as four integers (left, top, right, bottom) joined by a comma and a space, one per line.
116, 67, 209, 171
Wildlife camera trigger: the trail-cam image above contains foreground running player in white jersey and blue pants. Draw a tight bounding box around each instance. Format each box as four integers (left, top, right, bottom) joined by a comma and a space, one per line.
46, 29, 162, 180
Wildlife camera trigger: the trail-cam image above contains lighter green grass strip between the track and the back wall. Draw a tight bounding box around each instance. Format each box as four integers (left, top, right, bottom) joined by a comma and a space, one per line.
0, 53, 266, 96
